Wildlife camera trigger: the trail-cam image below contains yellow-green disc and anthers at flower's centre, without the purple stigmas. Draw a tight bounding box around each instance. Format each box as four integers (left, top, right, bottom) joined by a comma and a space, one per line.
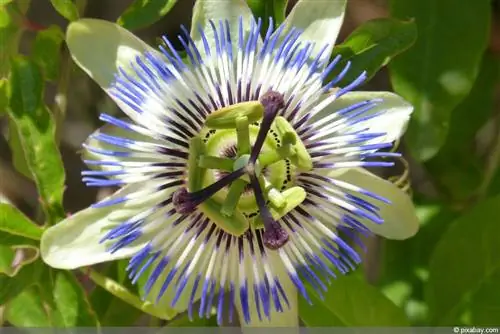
188, 103, 312, 236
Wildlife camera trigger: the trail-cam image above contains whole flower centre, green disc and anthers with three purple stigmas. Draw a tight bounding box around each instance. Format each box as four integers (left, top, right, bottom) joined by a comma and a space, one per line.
173, 92, 312, 249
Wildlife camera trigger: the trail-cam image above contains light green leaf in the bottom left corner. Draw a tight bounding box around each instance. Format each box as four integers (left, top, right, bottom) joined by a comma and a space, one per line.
5, 285, 52, 327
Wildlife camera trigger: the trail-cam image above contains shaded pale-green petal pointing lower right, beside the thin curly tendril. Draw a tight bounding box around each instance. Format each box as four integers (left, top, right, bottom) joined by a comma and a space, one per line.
330, 168, 420, 240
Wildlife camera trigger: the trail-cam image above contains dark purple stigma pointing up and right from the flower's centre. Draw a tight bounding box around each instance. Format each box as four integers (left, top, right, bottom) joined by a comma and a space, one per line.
249, 91, 285, 164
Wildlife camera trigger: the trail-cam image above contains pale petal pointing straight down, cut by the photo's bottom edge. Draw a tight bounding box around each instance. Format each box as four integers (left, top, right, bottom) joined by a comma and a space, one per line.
235, 251, 299, 326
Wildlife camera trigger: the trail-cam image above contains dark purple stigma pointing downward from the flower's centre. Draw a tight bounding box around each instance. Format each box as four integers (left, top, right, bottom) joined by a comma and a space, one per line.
250, 174, 289, 250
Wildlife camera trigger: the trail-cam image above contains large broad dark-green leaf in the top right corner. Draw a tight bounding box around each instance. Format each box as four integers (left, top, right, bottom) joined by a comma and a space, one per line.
390, 0, 491, 161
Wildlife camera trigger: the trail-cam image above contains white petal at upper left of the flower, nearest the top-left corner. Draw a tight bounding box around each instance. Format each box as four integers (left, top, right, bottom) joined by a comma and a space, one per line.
66, 19, 162, 121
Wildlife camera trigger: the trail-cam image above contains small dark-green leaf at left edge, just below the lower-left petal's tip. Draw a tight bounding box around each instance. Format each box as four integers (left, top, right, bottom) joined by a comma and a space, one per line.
0, 259, 44, 305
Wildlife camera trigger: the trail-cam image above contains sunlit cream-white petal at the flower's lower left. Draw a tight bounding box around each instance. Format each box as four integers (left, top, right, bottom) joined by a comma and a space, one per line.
40, 185, 165, 269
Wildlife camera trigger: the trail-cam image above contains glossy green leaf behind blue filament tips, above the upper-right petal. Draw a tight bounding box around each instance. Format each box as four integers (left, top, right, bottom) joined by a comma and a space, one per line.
330, 18, 417, 87
